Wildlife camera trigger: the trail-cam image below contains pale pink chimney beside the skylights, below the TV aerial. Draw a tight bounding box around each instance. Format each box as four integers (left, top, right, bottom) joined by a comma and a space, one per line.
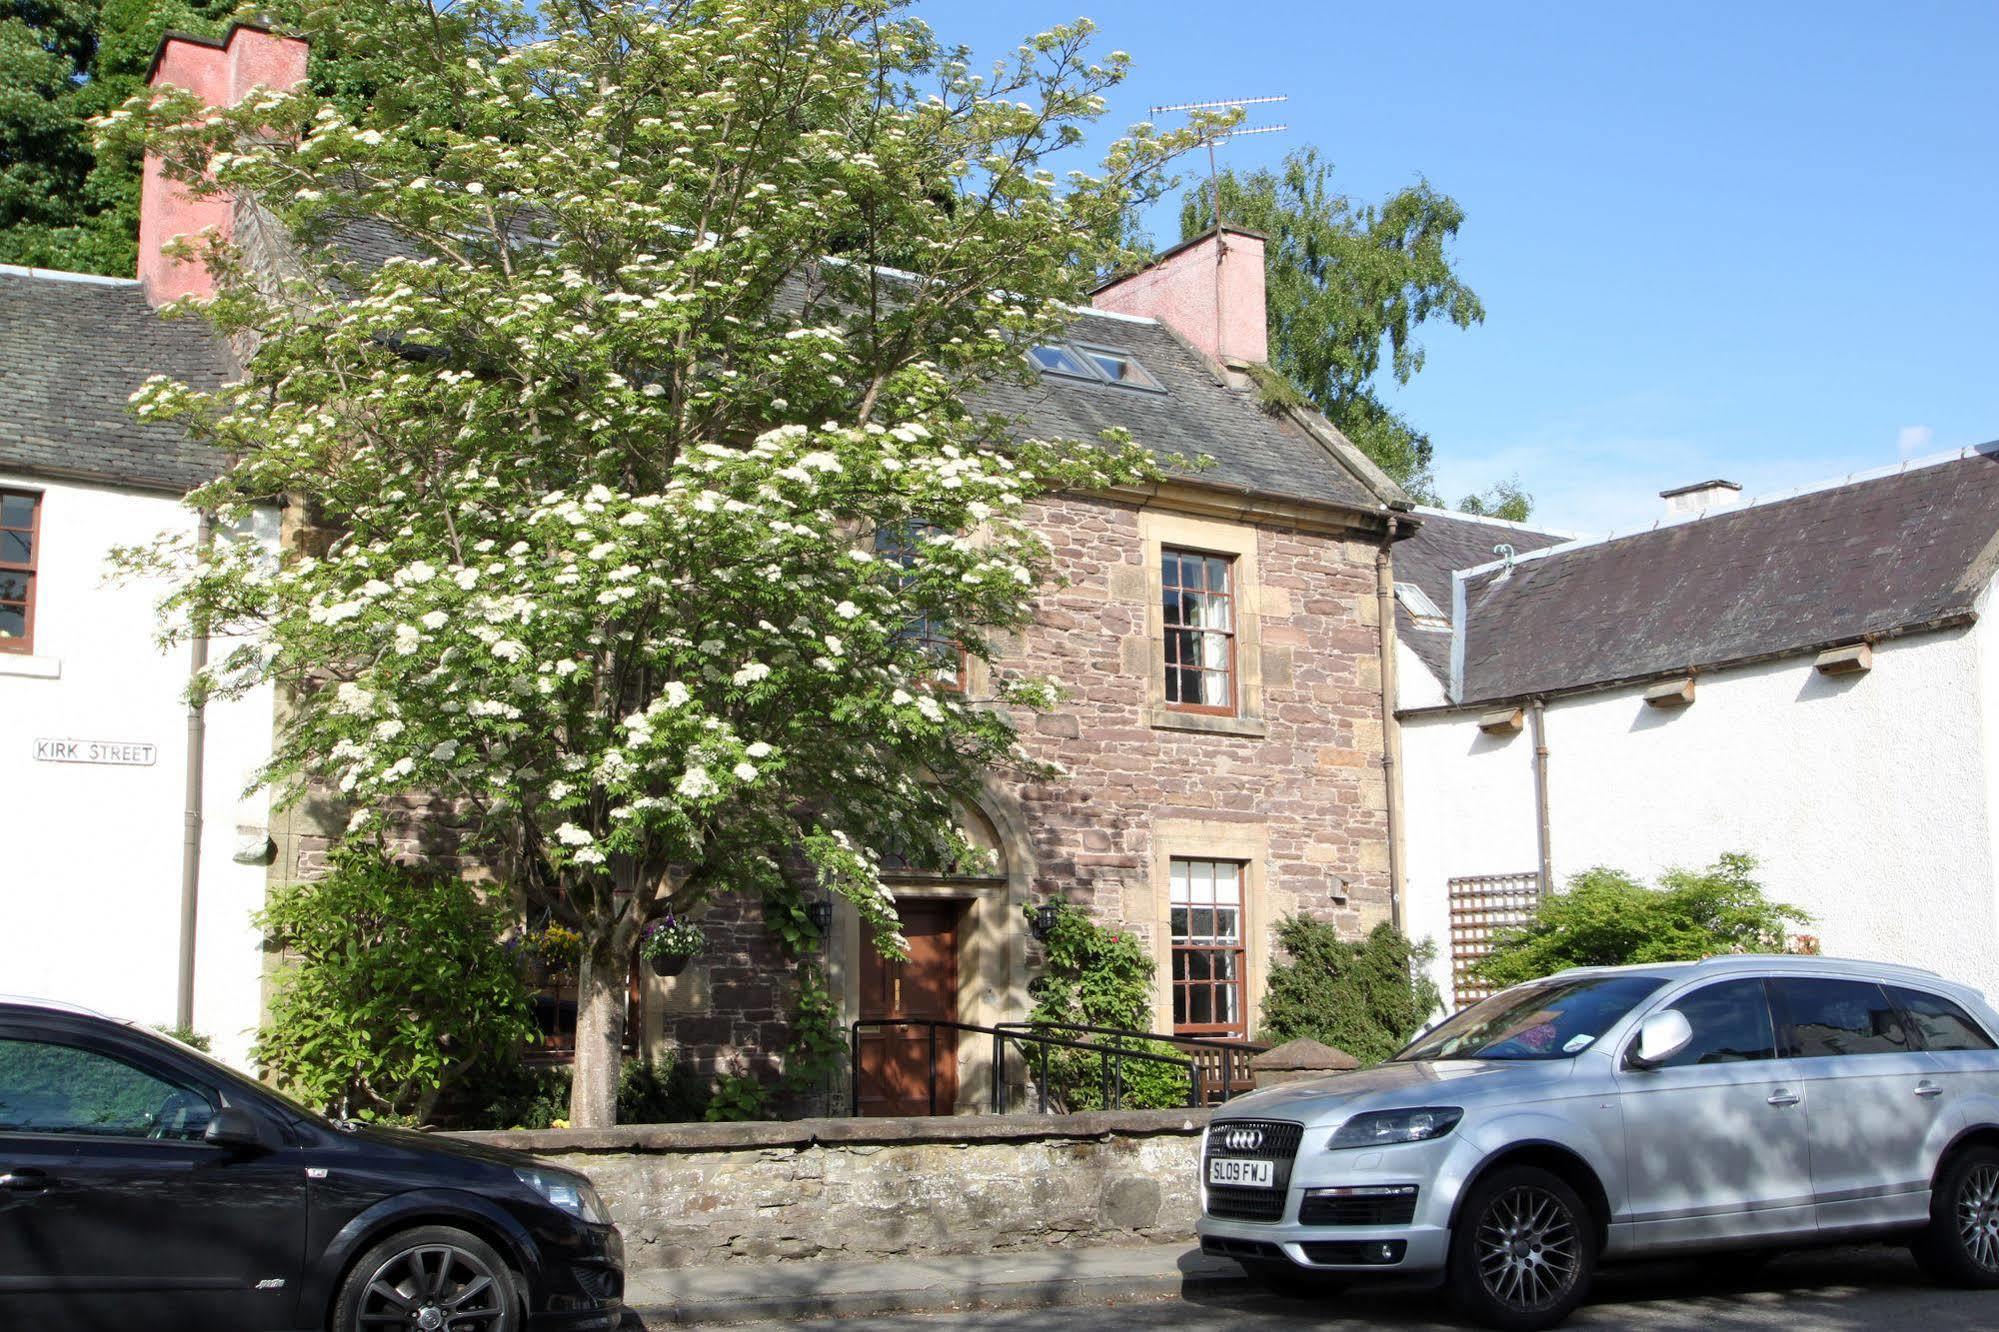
1089, 226, 1269, 366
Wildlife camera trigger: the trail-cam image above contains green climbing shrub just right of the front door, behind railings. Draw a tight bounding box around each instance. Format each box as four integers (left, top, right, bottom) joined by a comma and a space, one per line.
1021, 904, 1191, 1112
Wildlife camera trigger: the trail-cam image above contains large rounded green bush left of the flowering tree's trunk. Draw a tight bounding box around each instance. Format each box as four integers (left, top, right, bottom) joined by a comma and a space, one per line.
256, 840, 536, 1122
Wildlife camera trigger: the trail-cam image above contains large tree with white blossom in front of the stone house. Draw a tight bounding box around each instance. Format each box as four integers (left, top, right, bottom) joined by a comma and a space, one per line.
120, 0, 1211, 1126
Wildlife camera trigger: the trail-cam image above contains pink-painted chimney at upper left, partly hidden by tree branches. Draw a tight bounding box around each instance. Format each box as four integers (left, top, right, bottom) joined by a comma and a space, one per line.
138, 24, 306, 306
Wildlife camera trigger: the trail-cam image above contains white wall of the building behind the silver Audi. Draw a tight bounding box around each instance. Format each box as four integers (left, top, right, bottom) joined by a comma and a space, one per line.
1403, 618, 1999, 1008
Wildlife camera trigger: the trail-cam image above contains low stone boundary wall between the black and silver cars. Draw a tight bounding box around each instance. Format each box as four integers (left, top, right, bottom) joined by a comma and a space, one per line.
456, 1110, 1207, 1270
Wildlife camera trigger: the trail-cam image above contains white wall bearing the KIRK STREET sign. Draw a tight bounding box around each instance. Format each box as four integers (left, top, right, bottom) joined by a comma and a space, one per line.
0, 472, 278, 1066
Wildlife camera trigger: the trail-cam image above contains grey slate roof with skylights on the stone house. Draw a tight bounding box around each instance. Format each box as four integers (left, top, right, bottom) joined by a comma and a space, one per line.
978, 312, 1385, 512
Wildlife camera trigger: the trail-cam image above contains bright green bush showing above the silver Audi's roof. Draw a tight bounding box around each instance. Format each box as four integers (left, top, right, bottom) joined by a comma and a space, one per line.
1477, 852, 1811, 986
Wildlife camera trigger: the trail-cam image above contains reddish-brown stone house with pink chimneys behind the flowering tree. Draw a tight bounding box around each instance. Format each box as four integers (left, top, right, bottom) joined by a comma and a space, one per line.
3, 28, 1409, 1110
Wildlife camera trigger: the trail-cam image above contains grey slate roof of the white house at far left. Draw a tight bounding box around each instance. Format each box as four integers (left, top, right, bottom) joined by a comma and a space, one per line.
0, 268, 234, 494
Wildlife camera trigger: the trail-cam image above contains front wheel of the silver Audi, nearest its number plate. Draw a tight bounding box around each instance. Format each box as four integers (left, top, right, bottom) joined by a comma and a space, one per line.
1445, 1166, 1597, 1332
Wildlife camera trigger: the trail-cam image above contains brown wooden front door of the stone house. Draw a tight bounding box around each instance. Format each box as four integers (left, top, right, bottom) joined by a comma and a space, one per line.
856, 900, 964, 1114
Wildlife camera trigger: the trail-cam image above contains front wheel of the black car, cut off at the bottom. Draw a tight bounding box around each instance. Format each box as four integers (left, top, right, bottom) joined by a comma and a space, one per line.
332, 1226, 522, 1332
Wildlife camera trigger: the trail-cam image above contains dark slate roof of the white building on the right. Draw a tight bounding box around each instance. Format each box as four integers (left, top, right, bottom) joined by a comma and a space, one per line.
1439, 442, 1999, 704
